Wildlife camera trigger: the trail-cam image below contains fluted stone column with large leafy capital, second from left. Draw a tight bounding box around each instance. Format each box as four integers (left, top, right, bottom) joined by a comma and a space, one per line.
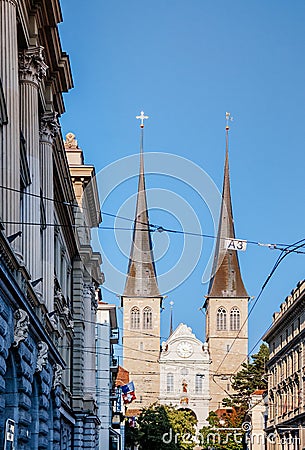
19, 47, 47, 280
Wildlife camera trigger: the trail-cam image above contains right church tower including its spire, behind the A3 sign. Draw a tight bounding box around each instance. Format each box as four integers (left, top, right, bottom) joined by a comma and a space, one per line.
204, 126, 249, 411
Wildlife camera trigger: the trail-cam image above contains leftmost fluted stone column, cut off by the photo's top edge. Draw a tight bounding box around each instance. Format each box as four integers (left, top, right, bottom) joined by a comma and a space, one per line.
0, 0, 21, 239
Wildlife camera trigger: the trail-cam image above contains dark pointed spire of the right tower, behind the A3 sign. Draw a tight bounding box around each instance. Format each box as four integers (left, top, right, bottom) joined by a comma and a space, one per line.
207, 113, 248, 298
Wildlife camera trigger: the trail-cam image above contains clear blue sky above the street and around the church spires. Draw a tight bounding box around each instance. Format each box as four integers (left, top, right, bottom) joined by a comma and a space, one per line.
60, 0, 305, 356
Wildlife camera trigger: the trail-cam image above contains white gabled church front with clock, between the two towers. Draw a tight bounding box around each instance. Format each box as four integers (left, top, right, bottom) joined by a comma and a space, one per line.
160, 323, 210, 429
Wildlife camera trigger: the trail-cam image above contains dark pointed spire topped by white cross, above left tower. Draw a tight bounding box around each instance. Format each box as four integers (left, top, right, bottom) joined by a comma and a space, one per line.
123, 111, 161, 297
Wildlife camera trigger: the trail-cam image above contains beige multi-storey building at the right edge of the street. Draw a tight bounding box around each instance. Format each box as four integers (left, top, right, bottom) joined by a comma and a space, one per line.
263, 281, 305, 450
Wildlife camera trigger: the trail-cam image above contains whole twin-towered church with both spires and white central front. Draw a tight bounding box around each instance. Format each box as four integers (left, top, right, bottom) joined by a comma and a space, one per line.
121, 113, 249, 426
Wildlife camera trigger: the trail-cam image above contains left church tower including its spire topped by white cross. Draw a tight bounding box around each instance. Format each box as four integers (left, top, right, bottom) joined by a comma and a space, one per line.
121, 112, 162, 415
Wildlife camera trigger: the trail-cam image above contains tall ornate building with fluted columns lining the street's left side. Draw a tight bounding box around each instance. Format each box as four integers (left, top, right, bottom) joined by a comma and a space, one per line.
0, 0, 102, 450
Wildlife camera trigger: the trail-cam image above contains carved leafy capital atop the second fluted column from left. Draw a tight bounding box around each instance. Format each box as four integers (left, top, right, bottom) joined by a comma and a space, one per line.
19, 46, 48, 86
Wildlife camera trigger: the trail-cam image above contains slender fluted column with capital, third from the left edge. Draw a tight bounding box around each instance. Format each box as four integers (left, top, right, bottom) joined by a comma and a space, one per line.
40, 112, 59, 312
